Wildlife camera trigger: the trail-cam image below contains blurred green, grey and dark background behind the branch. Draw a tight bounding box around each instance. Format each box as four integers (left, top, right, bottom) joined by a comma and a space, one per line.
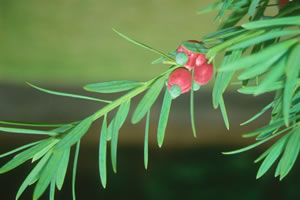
0, 0, 300, 200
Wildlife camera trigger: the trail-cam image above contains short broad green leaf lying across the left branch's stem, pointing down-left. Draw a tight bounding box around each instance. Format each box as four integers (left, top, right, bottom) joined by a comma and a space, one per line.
55, 116, 93, 150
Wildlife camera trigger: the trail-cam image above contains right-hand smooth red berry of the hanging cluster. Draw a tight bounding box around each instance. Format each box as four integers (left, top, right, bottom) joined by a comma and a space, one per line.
194, 63, 214, 85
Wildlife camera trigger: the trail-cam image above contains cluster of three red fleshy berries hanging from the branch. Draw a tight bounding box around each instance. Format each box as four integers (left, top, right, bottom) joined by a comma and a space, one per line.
168, 40, 214, 98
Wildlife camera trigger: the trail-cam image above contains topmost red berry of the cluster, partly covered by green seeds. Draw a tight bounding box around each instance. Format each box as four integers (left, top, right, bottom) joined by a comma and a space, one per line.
177, 40, 206, 69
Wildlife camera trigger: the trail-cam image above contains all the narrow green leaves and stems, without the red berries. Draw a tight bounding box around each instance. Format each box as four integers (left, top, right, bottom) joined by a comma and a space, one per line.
0, 0, 300, 199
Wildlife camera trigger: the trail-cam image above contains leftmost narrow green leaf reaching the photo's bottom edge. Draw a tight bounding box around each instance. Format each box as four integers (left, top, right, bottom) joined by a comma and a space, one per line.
16, 151, 52, 200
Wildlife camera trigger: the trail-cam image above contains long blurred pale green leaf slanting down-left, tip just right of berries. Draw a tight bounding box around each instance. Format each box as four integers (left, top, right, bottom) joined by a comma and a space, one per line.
219, 39, 297, 71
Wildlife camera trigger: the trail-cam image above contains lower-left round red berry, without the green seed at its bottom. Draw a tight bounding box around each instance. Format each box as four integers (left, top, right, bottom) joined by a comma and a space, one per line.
168, 68, 192, 94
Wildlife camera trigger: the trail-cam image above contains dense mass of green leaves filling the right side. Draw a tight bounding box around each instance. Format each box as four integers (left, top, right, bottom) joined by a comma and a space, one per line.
200, 0, 300, 180
